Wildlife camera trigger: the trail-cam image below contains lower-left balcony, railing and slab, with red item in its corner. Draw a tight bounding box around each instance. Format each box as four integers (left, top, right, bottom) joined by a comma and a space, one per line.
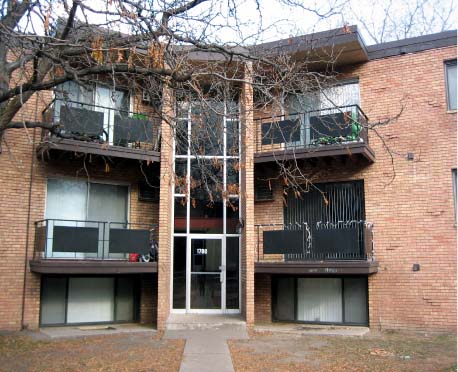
30, 219, 158, 274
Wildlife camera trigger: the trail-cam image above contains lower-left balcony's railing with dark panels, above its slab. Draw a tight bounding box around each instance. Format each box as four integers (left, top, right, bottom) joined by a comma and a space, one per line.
34, 219, 158, 261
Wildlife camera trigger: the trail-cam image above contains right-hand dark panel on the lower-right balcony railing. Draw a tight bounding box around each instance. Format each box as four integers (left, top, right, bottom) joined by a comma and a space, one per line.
312, 227, 361, 257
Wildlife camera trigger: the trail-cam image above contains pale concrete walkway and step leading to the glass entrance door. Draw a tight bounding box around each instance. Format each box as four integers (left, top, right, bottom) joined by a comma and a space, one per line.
164, 314, 248, 372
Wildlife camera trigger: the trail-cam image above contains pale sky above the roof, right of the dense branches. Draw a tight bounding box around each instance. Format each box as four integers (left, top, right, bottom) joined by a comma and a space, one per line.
200, 0, 458, 45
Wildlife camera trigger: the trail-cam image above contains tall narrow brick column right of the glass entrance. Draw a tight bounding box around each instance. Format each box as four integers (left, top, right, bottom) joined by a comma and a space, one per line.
241, 62, 255, 326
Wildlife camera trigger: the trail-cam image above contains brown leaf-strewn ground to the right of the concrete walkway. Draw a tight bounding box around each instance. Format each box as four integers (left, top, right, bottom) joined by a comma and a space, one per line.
229, 332, 457, 372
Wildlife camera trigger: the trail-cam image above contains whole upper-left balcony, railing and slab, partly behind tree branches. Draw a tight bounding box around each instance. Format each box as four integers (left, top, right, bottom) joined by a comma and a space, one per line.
38, 99, 160, 161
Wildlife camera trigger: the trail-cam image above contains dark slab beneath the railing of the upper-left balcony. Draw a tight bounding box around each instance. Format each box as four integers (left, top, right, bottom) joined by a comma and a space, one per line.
37, 137, 161, 162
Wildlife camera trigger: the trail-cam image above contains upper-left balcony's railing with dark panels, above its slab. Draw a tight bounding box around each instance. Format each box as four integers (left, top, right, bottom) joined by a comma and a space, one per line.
43, 98, 160, 151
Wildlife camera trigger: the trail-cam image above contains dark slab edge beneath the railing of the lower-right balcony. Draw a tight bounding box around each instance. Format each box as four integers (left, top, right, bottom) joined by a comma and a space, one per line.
254, 260, 379, 275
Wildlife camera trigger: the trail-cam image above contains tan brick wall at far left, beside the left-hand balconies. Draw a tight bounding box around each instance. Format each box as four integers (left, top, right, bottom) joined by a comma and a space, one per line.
0, 92, 49, 330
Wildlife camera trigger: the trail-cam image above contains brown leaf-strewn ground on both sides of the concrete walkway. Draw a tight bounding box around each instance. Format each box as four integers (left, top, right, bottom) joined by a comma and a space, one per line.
0, 326, 457, 372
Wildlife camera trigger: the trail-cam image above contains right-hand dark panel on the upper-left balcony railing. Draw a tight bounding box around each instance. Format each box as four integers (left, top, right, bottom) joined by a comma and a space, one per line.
114, 115, 153, 146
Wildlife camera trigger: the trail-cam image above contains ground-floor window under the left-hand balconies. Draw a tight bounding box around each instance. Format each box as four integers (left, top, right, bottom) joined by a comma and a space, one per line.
40, 276, 139, 325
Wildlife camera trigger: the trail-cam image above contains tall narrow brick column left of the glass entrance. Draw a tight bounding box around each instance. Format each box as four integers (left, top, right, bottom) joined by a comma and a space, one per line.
157, 86, 173, 329
